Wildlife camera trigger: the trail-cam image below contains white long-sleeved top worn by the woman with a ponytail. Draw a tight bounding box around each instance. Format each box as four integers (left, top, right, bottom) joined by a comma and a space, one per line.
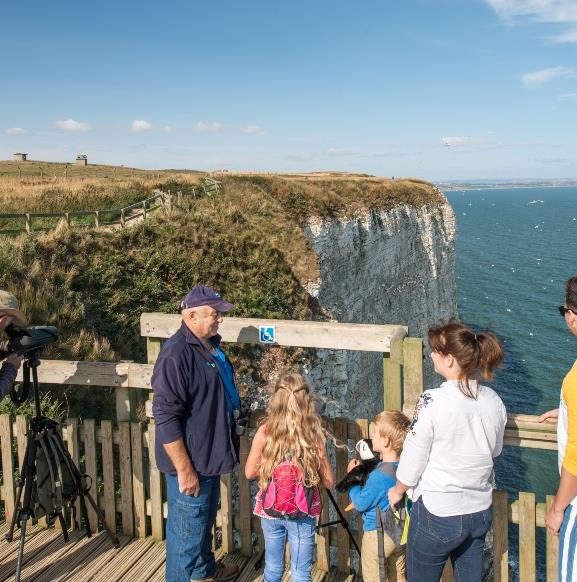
397, 380, 507, 517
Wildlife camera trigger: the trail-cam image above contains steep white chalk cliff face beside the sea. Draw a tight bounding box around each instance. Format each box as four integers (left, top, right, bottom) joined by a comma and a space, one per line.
305, 203, 457, 418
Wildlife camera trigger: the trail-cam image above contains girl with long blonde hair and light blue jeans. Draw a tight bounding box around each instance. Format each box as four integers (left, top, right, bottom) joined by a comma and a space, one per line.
245, 373, 334, 582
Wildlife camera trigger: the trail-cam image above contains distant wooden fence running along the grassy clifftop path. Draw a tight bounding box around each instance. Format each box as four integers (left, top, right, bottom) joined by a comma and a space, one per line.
0, 178, 220, 235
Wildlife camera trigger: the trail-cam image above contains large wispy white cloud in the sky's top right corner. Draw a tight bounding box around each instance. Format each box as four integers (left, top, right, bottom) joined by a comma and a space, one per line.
485, 0, 577, 43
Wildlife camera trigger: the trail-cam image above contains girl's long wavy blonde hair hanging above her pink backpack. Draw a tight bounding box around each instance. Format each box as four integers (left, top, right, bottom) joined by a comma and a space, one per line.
258, 373, 326, 488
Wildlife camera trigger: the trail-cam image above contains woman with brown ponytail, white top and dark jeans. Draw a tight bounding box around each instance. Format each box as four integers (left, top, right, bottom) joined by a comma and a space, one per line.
389, 322, 507, 582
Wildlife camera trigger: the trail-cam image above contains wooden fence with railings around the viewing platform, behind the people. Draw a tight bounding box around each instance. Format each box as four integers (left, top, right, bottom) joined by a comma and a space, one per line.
0, 314, 557, 582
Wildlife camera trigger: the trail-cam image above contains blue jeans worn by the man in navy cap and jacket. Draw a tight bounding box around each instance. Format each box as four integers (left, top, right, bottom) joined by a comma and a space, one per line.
165, 475, 220, 582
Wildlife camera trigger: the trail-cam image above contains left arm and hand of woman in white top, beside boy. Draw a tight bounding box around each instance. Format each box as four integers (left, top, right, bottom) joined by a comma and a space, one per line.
389, 391, 434, 507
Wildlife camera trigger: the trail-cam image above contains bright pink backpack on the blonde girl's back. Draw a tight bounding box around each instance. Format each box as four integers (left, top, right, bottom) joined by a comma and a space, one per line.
262, 461, 321, 519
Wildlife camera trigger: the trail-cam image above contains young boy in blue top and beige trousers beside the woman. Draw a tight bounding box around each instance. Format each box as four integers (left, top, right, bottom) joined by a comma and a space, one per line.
347, 410, 410, 582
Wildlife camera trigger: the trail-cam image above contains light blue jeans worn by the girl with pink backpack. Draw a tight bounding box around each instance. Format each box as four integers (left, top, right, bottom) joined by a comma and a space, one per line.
260, 517, 316, 582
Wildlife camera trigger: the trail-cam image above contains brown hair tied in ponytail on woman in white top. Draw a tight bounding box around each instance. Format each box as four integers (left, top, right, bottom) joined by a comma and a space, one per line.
428, 321, 503, 398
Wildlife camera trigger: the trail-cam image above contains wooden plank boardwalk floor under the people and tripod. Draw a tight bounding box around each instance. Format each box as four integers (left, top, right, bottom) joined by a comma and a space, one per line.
0, 523, 354, 582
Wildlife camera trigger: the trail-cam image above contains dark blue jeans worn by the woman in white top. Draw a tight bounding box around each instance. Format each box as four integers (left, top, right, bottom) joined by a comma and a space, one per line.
407, 497, 493, 582
